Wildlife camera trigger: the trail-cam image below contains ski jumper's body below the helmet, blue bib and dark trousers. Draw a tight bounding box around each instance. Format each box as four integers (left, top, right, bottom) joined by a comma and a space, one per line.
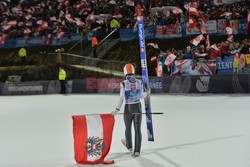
116, 76, 147, 153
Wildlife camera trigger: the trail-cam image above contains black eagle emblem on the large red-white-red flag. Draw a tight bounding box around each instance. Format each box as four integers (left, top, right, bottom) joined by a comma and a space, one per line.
86, 136, 104, 157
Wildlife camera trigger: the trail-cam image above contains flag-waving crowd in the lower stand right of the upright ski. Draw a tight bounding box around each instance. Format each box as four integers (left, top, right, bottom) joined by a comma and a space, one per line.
149, 39, 250, 76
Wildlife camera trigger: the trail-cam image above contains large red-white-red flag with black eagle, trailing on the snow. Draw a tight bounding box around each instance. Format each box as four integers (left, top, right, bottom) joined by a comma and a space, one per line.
72, 114, 115, 165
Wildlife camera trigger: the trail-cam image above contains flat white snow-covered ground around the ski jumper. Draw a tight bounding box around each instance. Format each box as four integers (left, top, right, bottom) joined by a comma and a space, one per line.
0, 95, 250, 167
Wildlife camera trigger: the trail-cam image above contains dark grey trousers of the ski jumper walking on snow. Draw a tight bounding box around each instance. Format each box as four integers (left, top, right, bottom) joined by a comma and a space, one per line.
124, 103, 142, 152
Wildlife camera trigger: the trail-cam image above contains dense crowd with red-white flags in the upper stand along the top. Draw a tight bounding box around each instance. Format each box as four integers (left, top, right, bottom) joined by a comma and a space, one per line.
0, 0, 250, 41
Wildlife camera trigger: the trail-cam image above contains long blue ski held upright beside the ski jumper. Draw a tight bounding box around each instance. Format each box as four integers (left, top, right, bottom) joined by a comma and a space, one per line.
137, 16, 154, 141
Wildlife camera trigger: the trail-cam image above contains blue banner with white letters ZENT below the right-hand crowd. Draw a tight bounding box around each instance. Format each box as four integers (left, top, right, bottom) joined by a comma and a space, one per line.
216, 56, 234, 74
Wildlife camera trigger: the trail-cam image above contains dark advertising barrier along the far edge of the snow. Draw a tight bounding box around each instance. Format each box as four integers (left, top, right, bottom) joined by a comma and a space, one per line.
0, 74, 250, 95
